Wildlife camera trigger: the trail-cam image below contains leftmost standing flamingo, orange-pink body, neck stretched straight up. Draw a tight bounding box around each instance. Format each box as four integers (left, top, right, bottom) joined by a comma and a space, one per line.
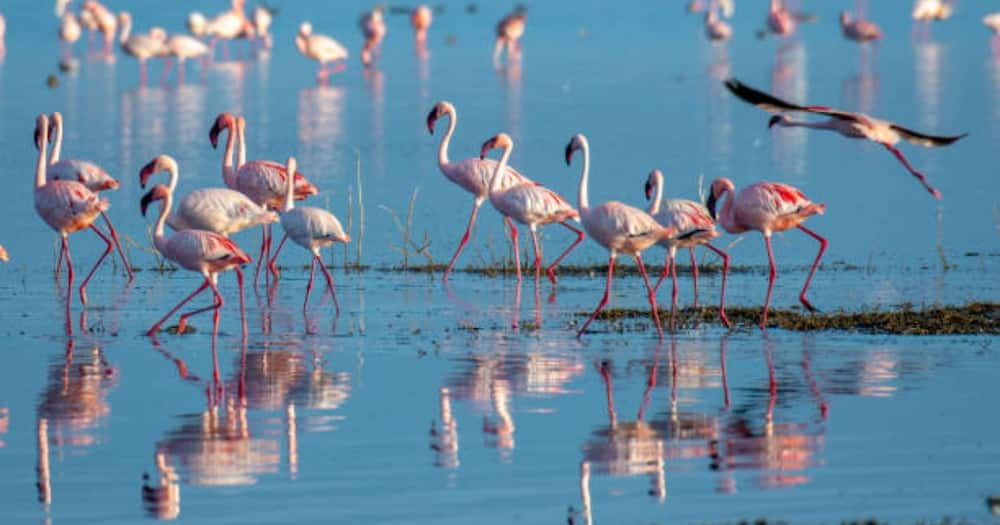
35, 114, 111, 333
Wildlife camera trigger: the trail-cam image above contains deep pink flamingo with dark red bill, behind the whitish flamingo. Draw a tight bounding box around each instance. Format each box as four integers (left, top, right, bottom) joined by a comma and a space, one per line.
208, 113, 319, 286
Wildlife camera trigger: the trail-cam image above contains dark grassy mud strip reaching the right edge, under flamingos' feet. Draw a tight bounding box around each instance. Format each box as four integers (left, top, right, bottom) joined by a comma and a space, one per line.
577, 303, 1000, 335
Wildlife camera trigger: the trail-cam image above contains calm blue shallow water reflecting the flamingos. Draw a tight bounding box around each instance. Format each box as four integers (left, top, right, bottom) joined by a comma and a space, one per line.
0, 2, 1000, 523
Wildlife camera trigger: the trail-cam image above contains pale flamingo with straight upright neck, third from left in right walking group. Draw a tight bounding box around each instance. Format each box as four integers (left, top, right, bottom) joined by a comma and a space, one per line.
566, 134, 677, 339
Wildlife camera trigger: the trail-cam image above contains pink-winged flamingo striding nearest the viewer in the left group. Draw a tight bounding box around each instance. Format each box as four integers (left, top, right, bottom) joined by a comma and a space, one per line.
140, 180, 251, 337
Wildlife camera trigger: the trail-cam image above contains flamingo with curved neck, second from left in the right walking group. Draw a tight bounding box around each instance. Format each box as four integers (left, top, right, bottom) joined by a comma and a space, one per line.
479, 133, 583, 284
